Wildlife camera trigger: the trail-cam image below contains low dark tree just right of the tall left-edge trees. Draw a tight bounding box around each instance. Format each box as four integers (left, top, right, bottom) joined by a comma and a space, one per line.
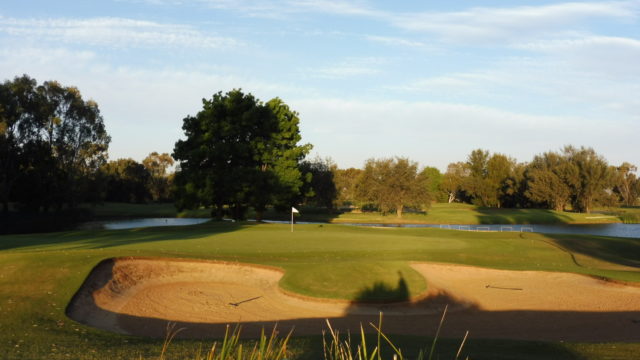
101, 159, 151, 203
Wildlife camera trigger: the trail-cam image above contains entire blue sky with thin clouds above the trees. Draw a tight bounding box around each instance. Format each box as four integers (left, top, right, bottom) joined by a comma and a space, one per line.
0, 0, 640, 170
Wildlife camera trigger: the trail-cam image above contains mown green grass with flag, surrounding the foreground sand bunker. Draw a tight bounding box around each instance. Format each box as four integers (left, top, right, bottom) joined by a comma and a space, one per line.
0, 223, 640, 359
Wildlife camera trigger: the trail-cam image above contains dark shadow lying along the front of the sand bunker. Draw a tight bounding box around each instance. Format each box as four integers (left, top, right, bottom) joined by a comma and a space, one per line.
66, 259, 640, 342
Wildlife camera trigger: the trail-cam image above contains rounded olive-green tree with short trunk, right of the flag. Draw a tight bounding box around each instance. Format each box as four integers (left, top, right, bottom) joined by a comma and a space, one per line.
357, 158, 431, 217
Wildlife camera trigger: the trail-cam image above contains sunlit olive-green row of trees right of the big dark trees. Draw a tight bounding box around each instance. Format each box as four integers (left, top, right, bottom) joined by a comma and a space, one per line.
311, 146, 640, 216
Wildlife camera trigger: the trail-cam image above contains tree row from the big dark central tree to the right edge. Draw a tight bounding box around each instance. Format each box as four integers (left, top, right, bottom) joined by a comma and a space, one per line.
173, 90, 640, 219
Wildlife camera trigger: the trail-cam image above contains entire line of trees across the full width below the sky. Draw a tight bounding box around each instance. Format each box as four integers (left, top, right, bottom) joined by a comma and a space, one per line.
0, 75, 640, 220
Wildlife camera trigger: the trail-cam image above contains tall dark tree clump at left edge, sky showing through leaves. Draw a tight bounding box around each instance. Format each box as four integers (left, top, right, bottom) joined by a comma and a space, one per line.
0, 75, 110, 211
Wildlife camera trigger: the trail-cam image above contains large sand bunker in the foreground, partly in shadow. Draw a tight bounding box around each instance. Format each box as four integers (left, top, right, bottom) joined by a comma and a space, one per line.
66, 257, 640, 341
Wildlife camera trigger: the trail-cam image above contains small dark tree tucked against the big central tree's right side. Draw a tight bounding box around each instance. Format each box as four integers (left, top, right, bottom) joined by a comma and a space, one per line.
300, 156, 338, 211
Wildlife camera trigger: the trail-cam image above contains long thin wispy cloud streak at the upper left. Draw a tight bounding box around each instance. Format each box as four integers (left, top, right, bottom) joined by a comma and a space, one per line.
0, 17, 242, 49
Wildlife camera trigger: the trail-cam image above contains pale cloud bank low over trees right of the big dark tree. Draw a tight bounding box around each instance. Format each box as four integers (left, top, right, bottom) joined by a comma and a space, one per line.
291, 98, 640, 170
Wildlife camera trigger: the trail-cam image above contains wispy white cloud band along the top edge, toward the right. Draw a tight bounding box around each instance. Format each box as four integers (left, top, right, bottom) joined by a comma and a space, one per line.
131, 0, 640, 46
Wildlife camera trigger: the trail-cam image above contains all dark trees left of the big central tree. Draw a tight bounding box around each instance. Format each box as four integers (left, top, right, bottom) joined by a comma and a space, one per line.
0, 75, 174, 214
